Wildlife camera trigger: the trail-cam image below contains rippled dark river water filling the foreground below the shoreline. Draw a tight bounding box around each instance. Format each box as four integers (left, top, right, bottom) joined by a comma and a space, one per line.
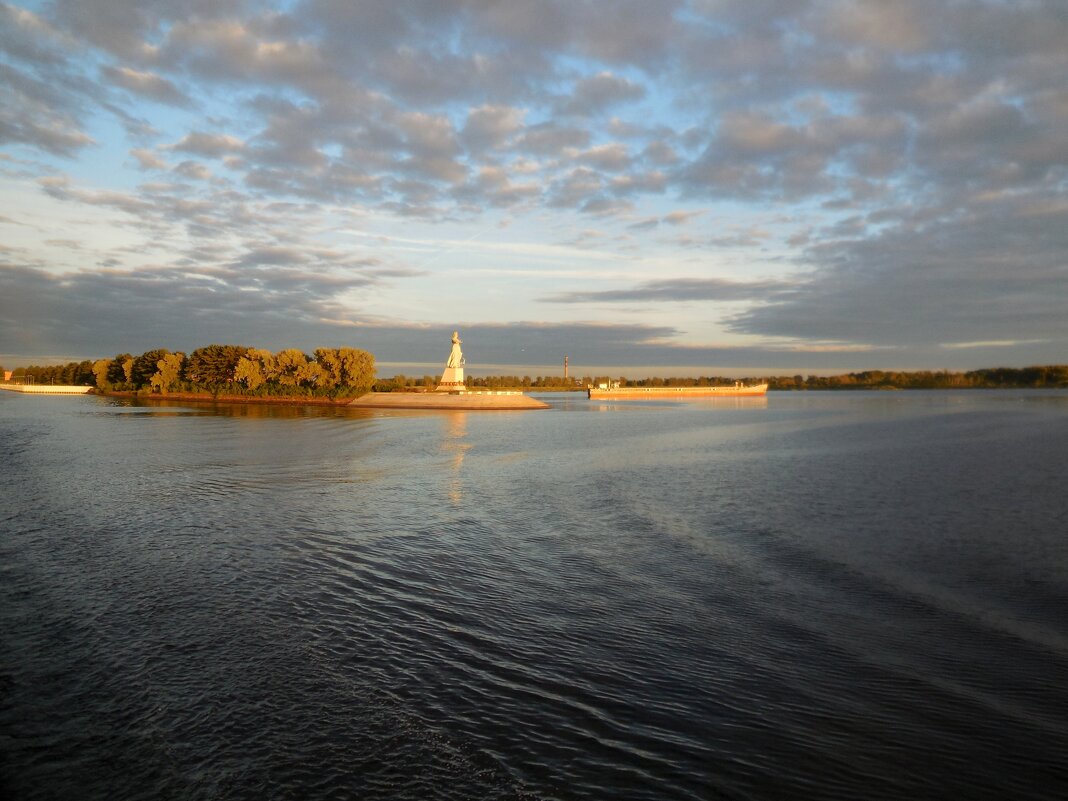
0, 391, 1068, 801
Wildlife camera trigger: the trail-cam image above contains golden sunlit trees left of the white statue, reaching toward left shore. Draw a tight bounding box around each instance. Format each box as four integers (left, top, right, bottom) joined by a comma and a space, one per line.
12, 345, 375, 397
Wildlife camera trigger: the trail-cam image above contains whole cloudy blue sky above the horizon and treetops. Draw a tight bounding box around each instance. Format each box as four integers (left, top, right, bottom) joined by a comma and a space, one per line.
0, 0, 1068, 375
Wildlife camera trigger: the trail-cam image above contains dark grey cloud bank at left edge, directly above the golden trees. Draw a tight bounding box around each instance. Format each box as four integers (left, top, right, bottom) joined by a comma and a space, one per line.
0, 242, 393, 358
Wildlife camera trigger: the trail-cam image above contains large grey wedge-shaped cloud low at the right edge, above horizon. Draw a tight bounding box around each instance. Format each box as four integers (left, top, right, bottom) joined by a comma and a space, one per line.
732, 194, 1068, 347
